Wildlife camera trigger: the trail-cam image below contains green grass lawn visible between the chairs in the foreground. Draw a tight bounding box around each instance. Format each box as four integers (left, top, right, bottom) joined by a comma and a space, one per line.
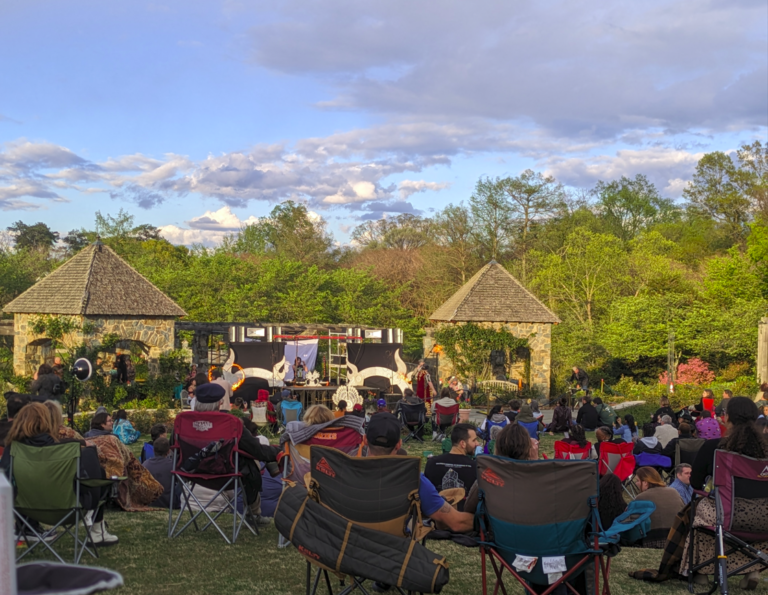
15, 412, 768, 595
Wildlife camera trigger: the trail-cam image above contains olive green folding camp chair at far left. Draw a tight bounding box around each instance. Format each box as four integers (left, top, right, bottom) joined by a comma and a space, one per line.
9, 442, 117, 564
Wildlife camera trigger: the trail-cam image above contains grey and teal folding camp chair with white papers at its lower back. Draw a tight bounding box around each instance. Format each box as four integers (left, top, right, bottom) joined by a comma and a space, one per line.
476, 455, 650, 595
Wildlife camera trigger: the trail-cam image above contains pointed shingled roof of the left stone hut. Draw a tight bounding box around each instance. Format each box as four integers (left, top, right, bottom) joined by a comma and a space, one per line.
4, 241, 186, 318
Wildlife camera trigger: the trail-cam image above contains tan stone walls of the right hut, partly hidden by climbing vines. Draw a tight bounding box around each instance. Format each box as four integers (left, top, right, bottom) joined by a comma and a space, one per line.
424, 322, 552, 398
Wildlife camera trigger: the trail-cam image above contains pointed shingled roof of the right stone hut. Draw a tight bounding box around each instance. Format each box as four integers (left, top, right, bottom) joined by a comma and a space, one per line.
429, 260, 560, 323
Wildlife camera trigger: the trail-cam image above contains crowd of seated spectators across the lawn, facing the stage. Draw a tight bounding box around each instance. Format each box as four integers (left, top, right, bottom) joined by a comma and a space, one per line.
0, 362, 768, 591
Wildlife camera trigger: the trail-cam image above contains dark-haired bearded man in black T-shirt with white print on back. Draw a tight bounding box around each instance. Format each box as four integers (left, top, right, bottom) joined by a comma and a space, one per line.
424, 424, 479, 510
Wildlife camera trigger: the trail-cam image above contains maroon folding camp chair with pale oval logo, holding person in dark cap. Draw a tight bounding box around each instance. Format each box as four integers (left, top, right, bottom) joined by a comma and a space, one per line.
168, 411, 258, 545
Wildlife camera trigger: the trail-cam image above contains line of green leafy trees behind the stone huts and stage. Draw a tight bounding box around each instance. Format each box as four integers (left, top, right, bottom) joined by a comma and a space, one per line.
0, 142, 768, 394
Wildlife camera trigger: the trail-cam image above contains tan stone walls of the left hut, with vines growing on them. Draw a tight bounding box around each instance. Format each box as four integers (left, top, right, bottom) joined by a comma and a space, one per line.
13, 314, 174, 376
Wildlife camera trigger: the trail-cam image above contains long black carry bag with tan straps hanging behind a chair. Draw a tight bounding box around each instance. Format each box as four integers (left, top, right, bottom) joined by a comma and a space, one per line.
275, 482, 448, 593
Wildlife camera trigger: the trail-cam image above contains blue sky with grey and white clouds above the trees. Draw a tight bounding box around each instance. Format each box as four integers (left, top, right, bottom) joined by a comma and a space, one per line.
0, 0, 768, 246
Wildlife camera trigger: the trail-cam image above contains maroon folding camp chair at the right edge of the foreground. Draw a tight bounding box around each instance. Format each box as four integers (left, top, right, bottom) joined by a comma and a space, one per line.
688, 450, 768, 595
